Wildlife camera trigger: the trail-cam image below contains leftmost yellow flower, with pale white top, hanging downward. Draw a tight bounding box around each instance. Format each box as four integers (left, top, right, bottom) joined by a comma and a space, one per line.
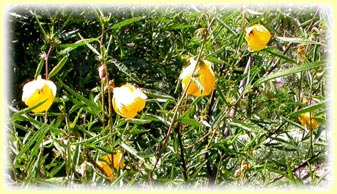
22, 76, 56, 113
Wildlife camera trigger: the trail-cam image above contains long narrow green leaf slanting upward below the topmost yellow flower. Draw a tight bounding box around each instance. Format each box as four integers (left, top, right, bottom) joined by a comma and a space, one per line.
254, 61, 325, 85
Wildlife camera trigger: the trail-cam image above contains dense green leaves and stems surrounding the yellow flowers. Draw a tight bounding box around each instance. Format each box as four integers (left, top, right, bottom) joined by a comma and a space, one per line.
6, 5, 329, 187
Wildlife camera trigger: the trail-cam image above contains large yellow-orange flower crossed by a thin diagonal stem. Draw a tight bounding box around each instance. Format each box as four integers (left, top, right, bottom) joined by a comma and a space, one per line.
179, 57, 216, 96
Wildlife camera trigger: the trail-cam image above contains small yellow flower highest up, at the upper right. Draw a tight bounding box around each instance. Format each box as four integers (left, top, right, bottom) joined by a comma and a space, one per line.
246, 24, 271, 51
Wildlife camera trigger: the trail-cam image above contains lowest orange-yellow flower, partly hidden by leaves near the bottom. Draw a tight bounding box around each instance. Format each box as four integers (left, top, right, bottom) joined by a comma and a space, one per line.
97, 150, 124, 180
